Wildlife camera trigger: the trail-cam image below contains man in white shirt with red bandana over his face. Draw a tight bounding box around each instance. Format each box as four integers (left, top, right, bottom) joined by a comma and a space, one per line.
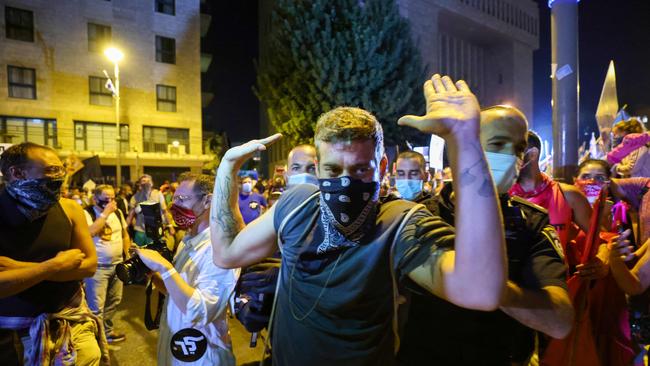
138, 173, 236, 366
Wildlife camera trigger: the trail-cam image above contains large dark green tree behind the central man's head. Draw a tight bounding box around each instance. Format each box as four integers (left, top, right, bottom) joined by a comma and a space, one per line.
255, 0, 428, 149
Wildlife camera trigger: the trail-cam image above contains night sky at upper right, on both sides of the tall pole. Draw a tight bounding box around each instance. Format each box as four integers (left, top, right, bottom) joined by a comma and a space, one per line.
533, 0, 650, 145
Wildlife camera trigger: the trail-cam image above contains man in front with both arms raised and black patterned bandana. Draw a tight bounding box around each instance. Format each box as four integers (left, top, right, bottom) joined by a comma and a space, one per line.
210, 75, 507, 366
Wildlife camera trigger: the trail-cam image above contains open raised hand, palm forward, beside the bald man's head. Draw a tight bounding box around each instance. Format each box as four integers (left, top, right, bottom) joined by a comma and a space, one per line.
397, 74, 481, 139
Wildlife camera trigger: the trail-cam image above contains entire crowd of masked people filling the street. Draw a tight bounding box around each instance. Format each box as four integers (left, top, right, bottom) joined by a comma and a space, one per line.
0, 75, 650, 366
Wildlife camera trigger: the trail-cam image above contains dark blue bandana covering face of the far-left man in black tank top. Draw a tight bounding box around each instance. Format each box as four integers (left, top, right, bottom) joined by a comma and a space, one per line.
7, 178, 63, 221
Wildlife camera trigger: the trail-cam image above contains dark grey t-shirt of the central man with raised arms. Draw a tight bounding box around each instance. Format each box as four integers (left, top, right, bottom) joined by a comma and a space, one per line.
272, 185, 453, 366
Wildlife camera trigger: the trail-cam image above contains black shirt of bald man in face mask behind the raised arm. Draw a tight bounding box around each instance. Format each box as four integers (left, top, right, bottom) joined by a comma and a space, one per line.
398, 186, 566, 366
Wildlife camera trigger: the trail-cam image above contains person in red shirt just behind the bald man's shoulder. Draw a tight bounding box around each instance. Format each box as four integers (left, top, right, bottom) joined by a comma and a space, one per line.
508, 131, 591, 252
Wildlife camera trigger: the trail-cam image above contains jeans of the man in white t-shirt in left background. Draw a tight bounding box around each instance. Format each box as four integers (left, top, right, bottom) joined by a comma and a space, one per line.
84, 264, 123, 334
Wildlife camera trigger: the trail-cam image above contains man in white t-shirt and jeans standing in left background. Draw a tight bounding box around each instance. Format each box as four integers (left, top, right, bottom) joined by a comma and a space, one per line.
84, 184, 131, 343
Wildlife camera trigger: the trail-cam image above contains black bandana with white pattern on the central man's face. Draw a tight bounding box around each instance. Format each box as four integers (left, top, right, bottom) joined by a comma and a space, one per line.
318, 177, 379, 252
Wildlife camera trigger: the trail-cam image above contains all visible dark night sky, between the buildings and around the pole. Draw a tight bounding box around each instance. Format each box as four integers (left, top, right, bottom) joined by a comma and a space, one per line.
204, 0, 650, 147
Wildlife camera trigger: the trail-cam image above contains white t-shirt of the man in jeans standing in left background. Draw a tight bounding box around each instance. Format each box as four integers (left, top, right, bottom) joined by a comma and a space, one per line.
84, 206, 126, 264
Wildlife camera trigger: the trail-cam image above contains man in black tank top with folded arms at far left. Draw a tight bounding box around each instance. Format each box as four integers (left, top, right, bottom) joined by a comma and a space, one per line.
0, 142, 108, 365
